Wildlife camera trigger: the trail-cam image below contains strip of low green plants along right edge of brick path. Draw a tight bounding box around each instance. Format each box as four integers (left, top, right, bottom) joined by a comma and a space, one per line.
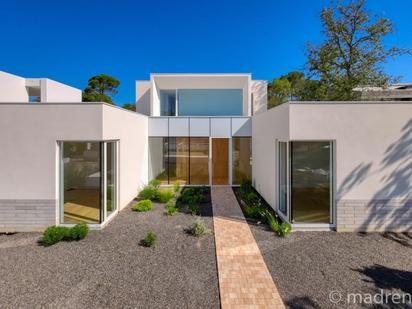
234, 179, 292, 237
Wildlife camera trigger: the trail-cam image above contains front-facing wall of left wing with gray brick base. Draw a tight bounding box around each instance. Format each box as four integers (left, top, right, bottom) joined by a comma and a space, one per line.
0, 103, 102, 231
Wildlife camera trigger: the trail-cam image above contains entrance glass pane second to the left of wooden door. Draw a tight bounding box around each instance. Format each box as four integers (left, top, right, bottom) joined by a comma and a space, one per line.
167, 137, 189, 184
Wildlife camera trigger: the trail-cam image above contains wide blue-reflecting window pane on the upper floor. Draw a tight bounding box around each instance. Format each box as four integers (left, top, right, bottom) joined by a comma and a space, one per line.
178, 89, 243, 116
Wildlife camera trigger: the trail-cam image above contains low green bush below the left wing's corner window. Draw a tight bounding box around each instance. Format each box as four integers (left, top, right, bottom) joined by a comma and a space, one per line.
41, 224, 89, 247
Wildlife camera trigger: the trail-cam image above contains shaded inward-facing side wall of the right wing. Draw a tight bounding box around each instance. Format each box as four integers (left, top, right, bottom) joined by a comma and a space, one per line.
252, 104, 289, 208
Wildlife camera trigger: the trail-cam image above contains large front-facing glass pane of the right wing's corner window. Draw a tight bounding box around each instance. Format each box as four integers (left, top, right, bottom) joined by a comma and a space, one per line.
291, 141, 332, 223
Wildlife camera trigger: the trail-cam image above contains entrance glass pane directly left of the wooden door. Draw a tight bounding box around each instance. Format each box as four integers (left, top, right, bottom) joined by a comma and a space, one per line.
190, 137, 209, 185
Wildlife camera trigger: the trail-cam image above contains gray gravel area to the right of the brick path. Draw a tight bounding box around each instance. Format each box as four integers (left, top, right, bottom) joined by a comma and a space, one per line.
250, 224, 412, 308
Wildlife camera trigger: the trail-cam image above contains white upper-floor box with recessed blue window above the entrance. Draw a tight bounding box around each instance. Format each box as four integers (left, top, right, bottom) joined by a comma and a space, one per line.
136, 74, 267, 117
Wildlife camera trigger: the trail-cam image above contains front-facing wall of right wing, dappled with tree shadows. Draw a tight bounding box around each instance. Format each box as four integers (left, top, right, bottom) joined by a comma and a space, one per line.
290, 102, 412, 231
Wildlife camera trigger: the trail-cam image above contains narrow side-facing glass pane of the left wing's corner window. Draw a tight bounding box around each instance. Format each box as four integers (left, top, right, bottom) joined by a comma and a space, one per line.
106, 142, 117, 216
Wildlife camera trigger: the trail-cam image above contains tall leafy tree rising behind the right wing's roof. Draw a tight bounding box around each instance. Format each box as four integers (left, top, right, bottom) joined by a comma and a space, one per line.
306, 0, 409, 100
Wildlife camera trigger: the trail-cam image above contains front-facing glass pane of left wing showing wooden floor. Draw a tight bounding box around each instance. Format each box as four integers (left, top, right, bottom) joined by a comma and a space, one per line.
62, 142, 101, 223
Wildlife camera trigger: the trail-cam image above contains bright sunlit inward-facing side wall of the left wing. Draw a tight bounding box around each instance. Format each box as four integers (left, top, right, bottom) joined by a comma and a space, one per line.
103, 105, 149, 209
